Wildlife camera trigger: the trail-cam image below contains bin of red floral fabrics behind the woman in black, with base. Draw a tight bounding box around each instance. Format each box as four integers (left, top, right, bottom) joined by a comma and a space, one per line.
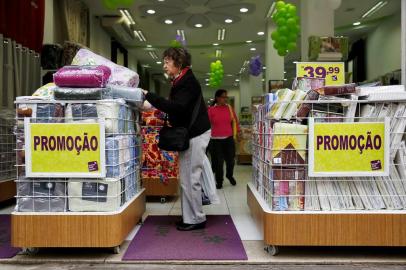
141, 109, 179, 203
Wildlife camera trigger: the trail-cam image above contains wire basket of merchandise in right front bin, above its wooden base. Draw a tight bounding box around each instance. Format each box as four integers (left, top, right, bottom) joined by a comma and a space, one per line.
253, 84, 406, 211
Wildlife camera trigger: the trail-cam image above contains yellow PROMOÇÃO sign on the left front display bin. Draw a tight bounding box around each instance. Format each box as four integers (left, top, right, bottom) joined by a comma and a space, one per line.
24, 118, 106, 177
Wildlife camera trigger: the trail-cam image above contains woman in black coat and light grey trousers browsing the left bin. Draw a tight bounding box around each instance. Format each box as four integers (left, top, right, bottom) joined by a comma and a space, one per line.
144, 48, 210, 231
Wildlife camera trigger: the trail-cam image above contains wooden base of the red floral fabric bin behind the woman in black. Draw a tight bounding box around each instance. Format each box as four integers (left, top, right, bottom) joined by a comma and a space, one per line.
142, 178, 179, 197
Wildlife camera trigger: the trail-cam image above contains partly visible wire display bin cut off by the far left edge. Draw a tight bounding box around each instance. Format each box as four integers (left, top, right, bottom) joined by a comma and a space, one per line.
0, 108, 16, 203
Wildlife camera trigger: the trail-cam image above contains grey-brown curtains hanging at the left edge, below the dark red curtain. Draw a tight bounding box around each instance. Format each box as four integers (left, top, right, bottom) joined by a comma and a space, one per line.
0, 34, 41, 108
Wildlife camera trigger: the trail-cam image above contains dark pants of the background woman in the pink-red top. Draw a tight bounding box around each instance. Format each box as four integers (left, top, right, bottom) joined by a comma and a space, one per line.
209, 136, 235, 185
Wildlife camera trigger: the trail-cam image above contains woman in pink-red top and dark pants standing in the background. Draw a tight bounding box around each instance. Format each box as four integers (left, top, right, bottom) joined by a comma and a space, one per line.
208, 89, 240, 189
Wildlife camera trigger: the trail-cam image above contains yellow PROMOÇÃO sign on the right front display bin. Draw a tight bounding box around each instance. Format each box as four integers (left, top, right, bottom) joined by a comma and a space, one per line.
309, 118, 390, 177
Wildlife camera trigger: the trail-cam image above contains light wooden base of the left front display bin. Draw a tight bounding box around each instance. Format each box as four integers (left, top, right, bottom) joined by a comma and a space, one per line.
11, 189, 145, 248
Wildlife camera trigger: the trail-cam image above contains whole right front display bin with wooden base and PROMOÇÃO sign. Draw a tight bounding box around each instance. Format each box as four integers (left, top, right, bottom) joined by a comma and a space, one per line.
247, 93, 406, 255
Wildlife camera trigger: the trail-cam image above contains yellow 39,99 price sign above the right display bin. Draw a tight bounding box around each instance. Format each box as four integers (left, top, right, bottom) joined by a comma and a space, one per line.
296, 62, 345, 86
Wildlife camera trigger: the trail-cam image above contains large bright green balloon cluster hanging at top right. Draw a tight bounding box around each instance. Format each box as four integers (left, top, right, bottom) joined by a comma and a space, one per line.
271, 1, 300, 56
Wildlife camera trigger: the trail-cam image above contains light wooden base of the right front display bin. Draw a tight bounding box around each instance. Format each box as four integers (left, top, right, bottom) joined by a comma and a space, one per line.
247, 183, 406, 251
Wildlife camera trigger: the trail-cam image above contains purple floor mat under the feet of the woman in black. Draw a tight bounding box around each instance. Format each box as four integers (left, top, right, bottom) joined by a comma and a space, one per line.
123, 215, 247, 261
